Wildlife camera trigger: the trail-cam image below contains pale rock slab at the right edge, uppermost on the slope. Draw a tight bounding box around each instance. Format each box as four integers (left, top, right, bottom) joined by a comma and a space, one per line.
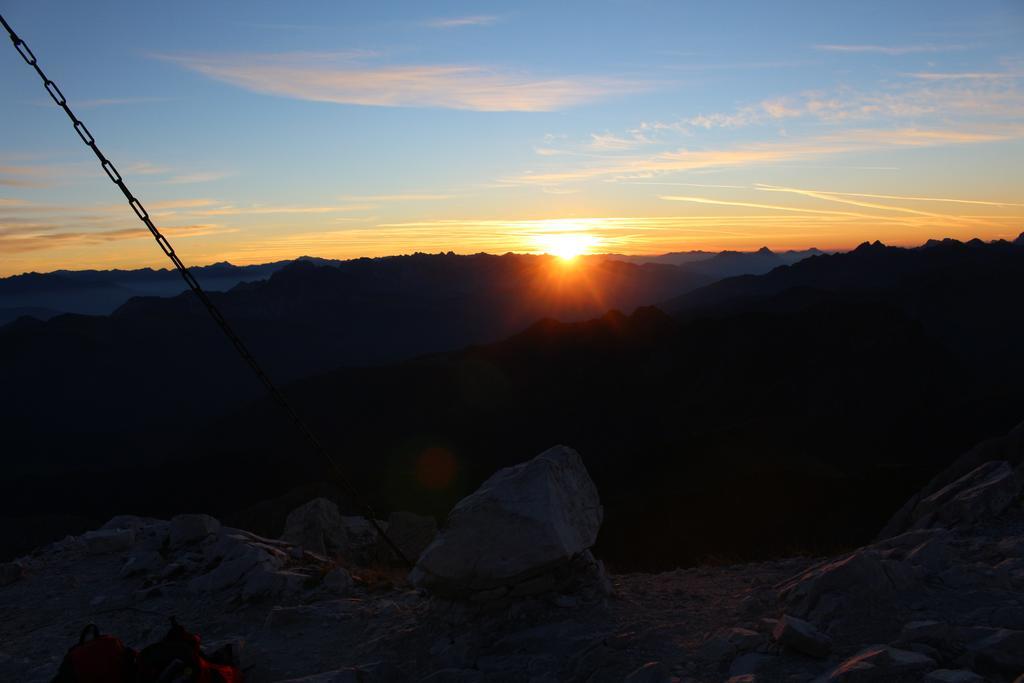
911, 461, 1021, 528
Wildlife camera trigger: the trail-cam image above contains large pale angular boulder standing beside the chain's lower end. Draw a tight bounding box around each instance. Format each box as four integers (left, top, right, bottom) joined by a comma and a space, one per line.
410, 445, 603, 597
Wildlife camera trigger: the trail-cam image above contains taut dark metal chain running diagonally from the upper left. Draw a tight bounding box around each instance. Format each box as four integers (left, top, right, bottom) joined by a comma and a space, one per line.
0, 14, 413, 567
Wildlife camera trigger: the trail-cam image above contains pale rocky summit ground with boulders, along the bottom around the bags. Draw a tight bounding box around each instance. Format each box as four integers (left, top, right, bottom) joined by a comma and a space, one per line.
0, 446, 1024, 683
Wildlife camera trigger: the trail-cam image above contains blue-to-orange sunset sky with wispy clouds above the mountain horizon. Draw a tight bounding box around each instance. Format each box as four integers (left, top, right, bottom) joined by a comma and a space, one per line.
0, 0, 1024, 275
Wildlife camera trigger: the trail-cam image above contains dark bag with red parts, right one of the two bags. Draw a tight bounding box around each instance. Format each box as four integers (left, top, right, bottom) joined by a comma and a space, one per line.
138, 618, 242, 683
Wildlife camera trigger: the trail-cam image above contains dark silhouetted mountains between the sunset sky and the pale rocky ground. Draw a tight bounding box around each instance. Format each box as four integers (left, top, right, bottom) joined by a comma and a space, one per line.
0, 235, 1024, 568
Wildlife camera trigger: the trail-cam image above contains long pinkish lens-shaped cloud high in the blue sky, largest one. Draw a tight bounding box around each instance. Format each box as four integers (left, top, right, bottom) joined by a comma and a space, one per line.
160, 53, 638, 112
